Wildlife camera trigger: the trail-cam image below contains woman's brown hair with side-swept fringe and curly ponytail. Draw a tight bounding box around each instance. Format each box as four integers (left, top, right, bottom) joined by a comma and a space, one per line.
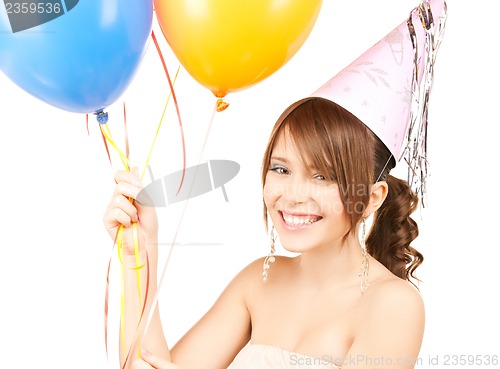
262, 97, 423, 280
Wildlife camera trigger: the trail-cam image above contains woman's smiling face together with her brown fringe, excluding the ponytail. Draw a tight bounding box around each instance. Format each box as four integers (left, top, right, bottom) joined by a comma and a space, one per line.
262, 98, 390, 250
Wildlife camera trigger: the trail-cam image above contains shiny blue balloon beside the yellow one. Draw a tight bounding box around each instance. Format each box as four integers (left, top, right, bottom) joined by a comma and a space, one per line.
0, 0, 153, 113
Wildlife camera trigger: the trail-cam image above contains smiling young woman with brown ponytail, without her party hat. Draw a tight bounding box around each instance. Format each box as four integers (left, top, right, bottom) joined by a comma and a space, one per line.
104, 97, 424, 369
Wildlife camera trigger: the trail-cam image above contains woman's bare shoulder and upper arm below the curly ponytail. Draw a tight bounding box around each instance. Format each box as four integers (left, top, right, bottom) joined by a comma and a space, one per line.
342, 281, 425, 369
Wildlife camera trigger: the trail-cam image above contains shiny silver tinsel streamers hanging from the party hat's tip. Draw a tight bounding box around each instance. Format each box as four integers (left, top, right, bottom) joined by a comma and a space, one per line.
404, 0, 447, 207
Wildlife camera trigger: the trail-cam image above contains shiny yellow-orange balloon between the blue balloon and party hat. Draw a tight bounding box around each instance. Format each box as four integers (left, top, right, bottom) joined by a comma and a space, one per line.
154, 0, 321, 98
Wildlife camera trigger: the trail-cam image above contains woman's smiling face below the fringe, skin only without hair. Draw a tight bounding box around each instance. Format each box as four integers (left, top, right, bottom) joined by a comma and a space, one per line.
264, 130, 350, 252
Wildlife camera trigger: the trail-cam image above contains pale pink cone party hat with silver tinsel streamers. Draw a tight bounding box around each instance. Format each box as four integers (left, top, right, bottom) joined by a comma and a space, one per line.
312, 0, 447, 195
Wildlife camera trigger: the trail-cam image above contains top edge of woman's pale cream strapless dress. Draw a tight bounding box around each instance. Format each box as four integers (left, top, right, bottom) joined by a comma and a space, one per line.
228, 342, 340, 369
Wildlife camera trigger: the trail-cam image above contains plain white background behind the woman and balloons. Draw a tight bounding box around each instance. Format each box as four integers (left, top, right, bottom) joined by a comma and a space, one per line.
0, 0, 500, 369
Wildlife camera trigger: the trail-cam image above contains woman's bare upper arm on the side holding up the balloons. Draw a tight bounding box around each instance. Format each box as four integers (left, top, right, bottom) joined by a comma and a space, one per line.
171, 262, 260, 369
